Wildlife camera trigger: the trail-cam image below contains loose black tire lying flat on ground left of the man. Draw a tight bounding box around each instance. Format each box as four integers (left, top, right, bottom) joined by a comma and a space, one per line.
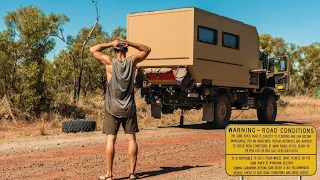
62, 119, 96, 133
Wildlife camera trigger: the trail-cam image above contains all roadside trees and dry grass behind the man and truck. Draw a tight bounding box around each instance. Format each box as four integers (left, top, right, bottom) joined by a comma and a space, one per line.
0, 6, 320, 138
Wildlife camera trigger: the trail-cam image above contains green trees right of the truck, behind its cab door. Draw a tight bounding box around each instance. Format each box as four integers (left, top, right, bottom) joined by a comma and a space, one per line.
260, 34, 320, 96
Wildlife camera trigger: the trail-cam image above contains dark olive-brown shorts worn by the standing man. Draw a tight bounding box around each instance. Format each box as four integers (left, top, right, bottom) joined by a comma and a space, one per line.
102, 111, 139, 135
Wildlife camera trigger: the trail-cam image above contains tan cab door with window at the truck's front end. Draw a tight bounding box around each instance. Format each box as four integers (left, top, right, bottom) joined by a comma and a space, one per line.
268, 56, 290, 92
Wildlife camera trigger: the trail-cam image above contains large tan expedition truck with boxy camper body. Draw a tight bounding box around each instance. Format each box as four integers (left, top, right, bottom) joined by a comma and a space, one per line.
127, 7, 289, 128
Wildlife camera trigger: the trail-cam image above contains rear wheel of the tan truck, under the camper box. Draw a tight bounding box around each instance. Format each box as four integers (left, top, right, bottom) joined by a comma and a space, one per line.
211, 95, 231, 129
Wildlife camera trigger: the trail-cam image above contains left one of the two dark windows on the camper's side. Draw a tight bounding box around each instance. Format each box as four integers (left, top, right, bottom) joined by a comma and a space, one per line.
198, 26, 217, 45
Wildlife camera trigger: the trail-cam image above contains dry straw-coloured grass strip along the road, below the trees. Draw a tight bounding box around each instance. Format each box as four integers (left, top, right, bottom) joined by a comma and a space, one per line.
0, 93, 320, 139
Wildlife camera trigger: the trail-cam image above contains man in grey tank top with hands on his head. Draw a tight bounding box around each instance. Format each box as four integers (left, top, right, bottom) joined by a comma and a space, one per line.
90, 39, 151, 180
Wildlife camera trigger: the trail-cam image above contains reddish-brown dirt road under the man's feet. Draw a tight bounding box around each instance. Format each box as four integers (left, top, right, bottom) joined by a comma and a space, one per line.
0, 115, 320, 180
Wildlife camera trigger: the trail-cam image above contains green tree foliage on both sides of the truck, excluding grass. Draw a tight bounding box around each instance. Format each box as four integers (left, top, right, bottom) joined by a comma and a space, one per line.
0, 6, 320, 118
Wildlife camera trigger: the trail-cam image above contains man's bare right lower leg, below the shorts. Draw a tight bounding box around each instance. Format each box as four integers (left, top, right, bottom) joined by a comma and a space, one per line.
126, 133, 138, 178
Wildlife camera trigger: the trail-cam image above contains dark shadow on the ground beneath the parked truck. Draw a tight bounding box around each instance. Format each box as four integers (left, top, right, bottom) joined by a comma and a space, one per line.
158, 120, 306, 130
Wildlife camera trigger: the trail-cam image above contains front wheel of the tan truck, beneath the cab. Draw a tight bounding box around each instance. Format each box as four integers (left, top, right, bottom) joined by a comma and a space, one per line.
257, 94, 278, 124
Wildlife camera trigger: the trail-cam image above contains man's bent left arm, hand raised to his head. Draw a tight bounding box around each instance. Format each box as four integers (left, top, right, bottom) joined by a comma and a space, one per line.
90, 41, 115, 65
